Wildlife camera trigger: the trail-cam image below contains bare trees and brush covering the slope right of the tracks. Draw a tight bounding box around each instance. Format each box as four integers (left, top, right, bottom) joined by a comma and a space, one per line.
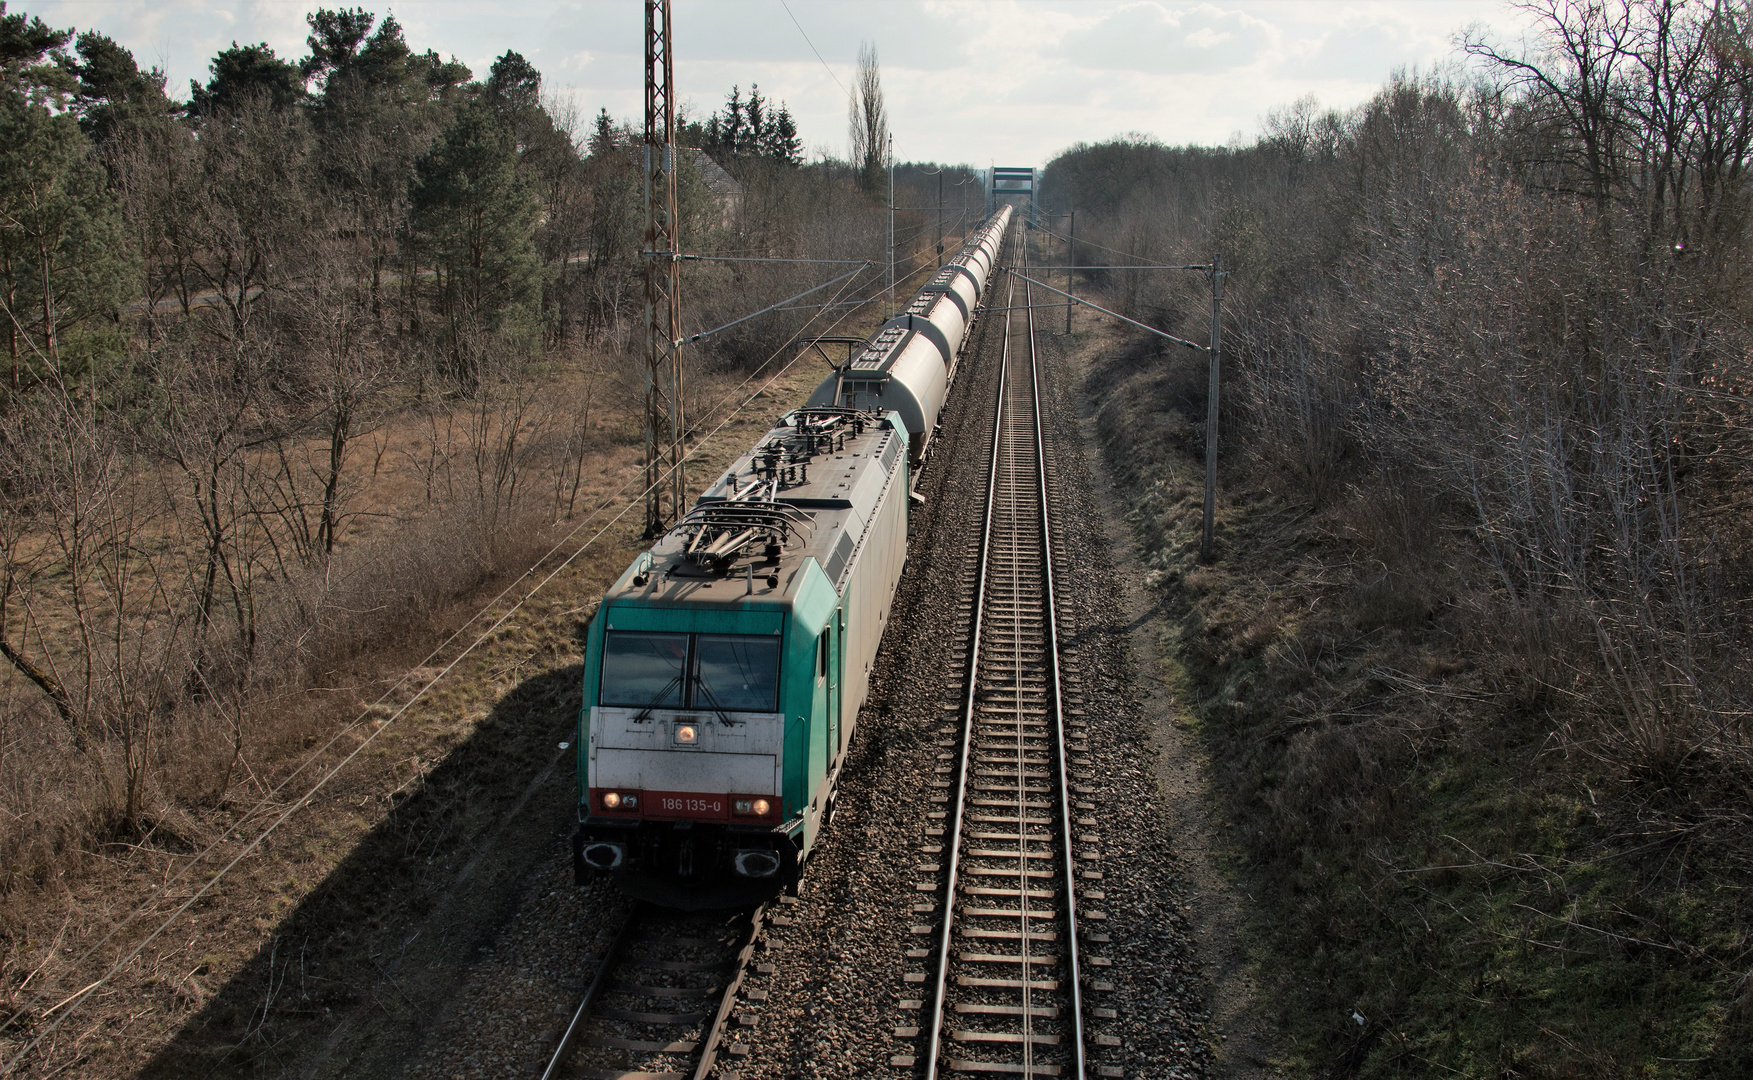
1043, 0, 1753, 1075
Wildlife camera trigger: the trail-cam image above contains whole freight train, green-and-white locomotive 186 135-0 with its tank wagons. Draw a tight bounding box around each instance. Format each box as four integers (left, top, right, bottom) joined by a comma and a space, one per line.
573, 207, 1010, 908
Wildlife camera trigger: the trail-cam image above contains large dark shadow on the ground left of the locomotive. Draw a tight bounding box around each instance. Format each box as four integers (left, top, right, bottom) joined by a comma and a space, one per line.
140, 664, 582, 1080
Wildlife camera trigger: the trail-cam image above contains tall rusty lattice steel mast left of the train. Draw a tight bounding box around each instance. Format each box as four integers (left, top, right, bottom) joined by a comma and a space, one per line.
645, 0, 687, 536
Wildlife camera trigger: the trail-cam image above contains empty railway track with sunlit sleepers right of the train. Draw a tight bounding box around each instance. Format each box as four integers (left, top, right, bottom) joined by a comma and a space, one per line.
891, 223, 1120, 1078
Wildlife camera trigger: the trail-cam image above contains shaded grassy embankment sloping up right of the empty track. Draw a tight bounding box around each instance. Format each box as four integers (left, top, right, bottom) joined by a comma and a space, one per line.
1080, 308, 1753, 1076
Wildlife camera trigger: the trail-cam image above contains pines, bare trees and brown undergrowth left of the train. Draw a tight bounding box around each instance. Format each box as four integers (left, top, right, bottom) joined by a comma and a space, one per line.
0, 5, 931, 892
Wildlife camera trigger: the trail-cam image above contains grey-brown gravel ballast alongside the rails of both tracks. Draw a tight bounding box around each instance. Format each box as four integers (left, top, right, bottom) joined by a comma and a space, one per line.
405, 266, 1211, 1080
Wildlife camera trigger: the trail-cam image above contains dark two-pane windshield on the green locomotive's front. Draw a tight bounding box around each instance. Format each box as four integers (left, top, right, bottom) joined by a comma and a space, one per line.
598, 629, 778, 712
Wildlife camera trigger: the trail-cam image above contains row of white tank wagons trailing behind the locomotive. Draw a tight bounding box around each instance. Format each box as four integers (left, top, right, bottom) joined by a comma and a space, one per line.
806, 207, 1011, 461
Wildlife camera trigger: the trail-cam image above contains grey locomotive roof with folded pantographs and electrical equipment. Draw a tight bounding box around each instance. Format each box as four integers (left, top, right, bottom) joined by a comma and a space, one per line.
603, 410, 906, 607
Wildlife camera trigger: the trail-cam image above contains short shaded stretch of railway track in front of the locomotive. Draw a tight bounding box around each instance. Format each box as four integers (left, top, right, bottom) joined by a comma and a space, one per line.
542, 903, 771, 1080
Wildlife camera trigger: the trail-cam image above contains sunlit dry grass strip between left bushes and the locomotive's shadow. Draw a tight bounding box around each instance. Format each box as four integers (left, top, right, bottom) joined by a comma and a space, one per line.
0, 350, 820, 1076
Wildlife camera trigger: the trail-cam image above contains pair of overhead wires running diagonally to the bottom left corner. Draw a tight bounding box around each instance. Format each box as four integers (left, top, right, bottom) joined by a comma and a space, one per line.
0, 257, 876, 1075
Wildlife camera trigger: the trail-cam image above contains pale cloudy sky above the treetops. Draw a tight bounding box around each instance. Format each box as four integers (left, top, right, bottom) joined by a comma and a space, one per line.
34, 0, 1549, 167
